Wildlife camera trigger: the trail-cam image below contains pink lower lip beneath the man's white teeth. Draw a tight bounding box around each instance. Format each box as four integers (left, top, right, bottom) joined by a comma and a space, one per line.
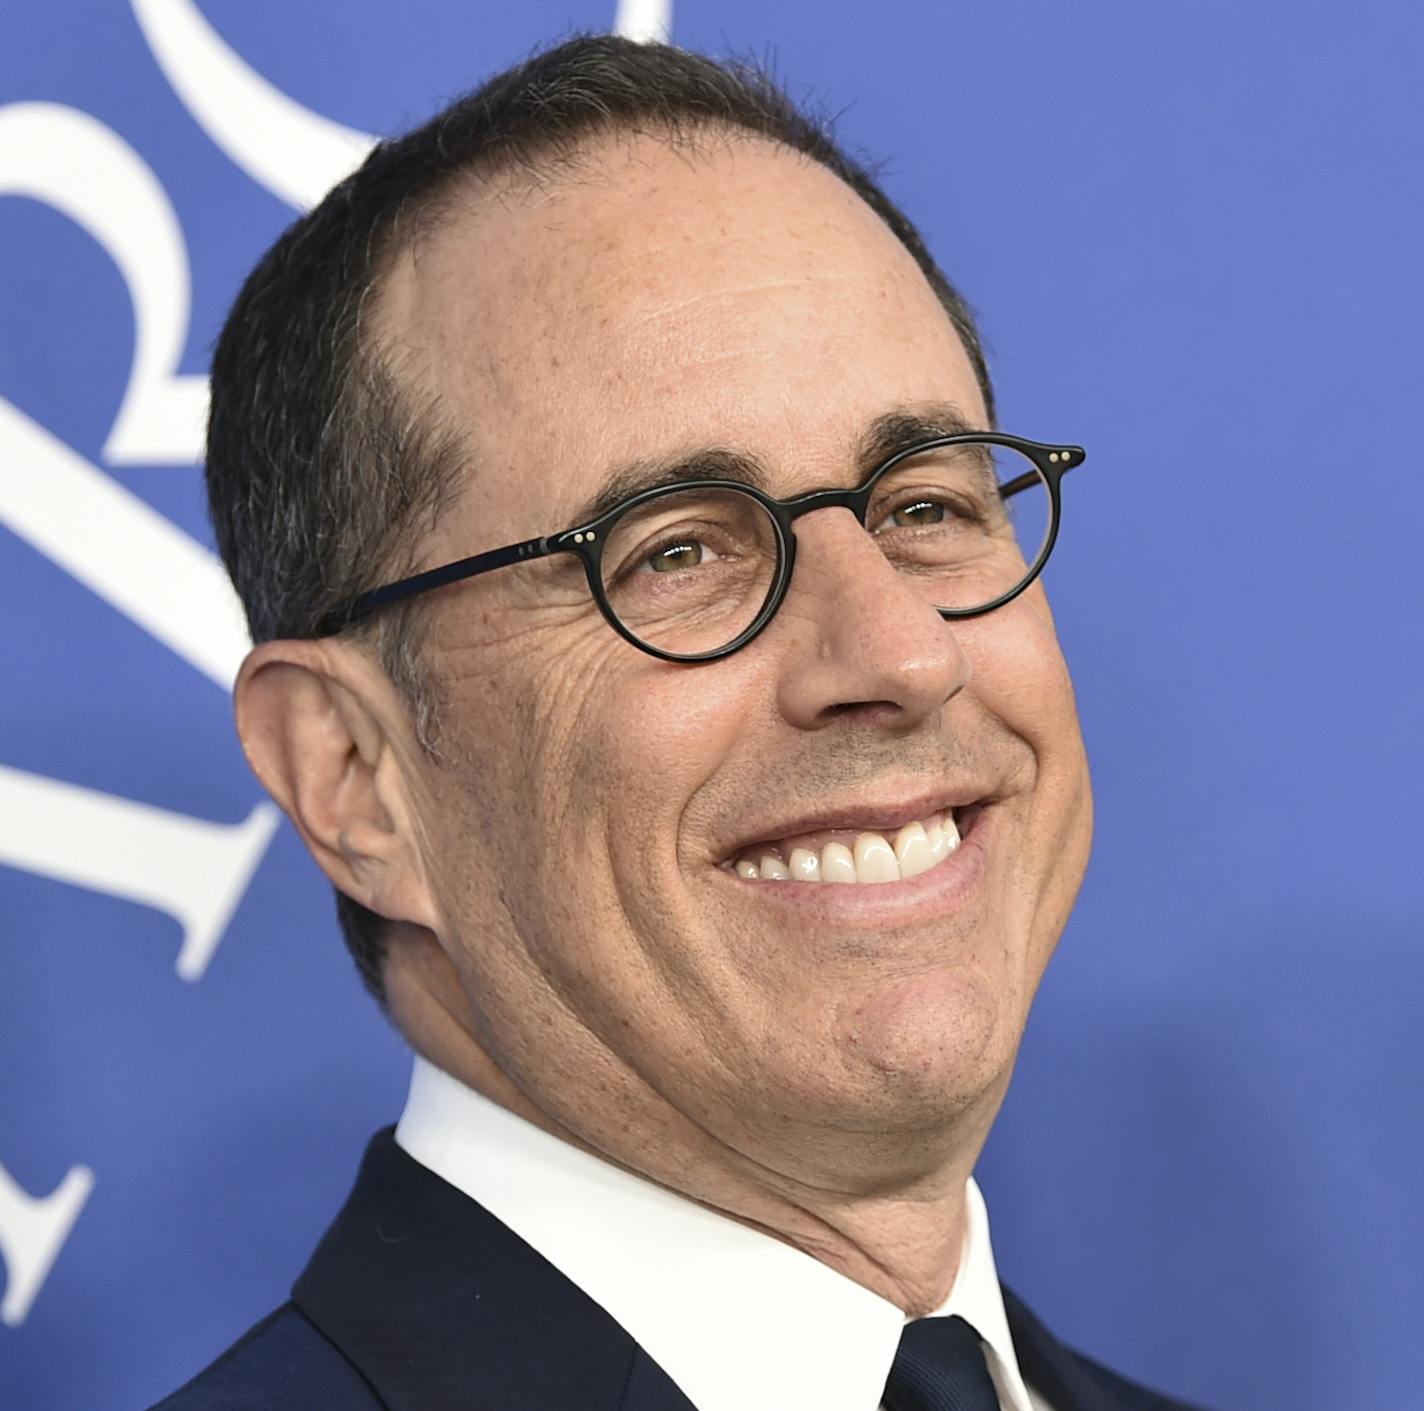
713, 803, 1000, 925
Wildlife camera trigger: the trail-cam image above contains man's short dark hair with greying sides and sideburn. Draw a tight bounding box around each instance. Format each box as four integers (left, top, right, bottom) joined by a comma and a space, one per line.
206, 36, 994, 1005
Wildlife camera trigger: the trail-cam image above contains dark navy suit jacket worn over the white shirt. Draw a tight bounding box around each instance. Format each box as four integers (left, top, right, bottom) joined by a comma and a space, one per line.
154, 1128, 1213, 1411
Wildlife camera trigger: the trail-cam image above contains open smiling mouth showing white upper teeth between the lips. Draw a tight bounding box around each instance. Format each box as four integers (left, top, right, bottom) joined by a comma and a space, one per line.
721, 799, 990, 887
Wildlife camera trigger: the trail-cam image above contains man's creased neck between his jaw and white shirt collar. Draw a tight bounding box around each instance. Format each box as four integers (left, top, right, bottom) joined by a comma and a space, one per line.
392, 945, 1002, 1317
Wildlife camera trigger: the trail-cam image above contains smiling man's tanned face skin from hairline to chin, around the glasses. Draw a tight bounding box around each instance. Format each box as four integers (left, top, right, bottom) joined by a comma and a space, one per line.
380, 138, 1091, 1186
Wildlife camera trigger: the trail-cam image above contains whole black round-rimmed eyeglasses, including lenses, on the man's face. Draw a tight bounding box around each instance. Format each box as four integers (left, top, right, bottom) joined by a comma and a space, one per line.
318, 431, 1087, 662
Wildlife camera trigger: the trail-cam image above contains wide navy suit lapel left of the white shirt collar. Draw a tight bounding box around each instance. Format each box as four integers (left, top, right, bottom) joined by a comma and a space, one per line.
292, 1128, 692, 1411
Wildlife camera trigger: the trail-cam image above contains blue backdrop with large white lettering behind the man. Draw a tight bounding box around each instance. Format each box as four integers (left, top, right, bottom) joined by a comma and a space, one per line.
0, 0, 1424, 1411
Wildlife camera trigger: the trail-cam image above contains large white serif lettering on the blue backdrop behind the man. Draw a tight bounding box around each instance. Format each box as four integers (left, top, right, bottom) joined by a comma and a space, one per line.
0, 0, 672, 1327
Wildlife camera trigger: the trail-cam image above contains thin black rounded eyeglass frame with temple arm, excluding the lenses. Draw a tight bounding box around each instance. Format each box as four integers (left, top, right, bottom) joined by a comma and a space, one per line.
313, 431, 1088, 663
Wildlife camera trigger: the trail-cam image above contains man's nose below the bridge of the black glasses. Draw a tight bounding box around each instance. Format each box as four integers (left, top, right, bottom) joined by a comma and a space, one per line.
768, 508, 970, 733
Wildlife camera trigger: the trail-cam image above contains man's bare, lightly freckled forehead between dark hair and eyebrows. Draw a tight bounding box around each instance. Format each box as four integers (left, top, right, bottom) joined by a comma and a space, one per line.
377, 135, 984, 551
